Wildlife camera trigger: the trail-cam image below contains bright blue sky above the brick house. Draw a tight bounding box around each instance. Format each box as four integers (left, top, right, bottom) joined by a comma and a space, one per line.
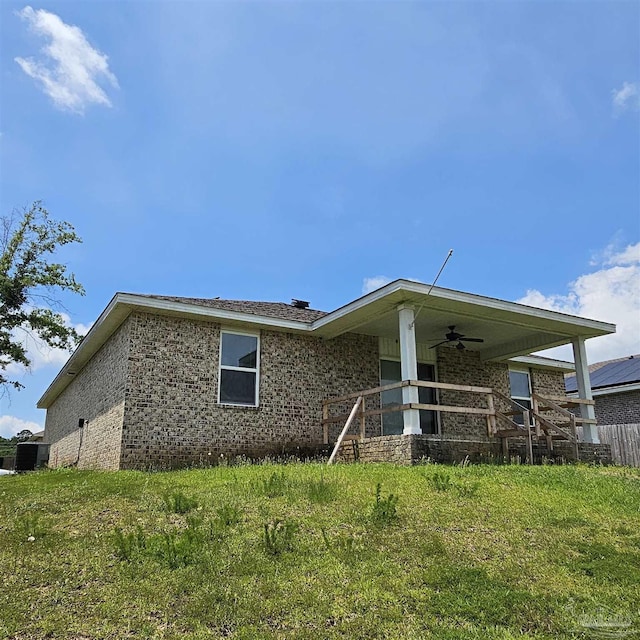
0, 0, 640, 435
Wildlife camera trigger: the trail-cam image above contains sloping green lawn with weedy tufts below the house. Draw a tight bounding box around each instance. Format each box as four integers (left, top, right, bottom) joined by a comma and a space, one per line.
0, 464, 640, 640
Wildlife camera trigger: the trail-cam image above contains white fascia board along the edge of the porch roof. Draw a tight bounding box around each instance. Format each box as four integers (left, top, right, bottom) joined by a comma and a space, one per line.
311, 280, 616, 337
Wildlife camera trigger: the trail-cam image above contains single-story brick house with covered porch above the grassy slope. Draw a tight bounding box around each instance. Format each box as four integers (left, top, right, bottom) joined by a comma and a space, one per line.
38, 280, 615, 469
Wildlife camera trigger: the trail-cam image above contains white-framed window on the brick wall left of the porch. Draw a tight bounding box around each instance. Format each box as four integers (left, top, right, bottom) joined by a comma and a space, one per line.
218, 331, 260, 407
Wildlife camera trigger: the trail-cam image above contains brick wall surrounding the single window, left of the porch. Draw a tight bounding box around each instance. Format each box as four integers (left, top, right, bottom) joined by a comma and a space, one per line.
120, 313, 379, 468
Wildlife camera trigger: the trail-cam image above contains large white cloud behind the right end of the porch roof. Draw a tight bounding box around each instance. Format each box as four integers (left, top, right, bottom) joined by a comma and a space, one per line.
518, 242, 640, 362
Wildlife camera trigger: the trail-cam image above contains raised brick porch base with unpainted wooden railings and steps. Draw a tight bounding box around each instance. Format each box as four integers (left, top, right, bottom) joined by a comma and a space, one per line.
322, 380, 610, 464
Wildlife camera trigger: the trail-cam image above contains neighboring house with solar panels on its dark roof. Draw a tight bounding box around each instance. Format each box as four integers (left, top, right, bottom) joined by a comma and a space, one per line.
565, 354, 640, 425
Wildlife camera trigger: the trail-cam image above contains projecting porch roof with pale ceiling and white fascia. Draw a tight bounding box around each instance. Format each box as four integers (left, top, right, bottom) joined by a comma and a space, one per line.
313, 280, 615, 360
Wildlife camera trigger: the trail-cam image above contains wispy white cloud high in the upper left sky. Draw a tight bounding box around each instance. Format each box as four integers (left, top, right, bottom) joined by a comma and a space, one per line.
15, 6, 118, 113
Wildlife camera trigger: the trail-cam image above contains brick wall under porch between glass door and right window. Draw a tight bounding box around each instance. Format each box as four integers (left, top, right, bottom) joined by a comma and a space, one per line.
438, 347, 509, 440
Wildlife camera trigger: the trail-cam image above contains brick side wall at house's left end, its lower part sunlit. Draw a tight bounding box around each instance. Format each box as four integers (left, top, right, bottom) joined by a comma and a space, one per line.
45, 320, 130, 469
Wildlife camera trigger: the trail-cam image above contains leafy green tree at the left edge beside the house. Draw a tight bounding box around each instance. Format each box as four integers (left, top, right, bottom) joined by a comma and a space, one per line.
0, 201, 84, 389
